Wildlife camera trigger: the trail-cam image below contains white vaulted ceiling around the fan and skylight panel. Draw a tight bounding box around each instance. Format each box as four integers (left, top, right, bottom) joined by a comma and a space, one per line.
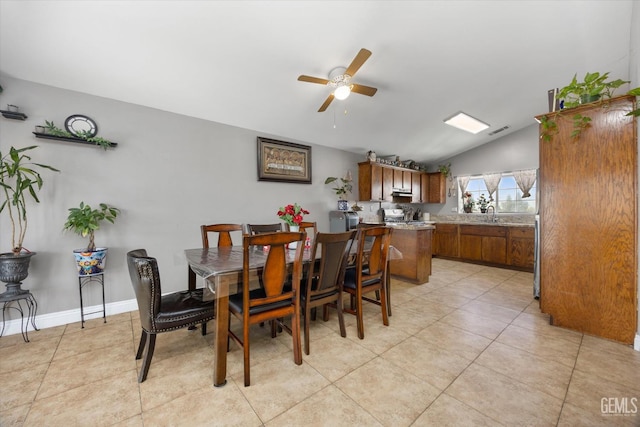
0, 0, 640, 163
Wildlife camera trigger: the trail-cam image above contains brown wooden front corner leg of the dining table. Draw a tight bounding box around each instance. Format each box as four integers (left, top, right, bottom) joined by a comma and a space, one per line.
207, 277, 229, 387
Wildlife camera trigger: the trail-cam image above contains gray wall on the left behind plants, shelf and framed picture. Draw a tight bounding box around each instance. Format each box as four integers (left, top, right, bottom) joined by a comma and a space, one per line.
0, 76, 366, 315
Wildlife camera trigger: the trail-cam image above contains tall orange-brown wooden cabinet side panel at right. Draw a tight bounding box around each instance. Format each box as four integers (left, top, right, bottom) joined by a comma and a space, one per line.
538, 96, 638, 344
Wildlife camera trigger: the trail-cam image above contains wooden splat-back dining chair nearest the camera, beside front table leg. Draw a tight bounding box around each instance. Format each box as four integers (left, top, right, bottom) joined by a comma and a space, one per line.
229, 231, 305, 387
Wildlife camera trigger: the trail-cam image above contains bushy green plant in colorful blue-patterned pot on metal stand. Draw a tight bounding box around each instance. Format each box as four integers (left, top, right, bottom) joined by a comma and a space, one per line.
63, 202, 120, 276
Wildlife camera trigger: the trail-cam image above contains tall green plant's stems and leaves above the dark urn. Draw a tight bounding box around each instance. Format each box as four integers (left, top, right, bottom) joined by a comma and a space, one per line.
0, 145, 59, 256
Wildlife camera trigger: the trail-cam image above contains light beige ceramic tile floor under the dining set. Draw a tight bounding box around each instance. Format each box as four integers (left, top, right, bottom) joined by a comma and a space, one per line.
0, 259, 640, 427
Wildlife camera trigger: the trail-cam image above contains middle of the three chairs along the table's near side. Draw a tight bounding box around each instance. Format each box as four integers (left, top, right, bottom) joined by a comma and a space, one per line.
300, 230, 356, 354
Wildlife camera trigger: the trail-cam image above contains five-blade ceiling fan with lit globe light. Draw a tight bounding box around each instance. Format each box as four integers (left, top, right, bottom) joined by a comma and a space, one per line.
298, 49, 378, 113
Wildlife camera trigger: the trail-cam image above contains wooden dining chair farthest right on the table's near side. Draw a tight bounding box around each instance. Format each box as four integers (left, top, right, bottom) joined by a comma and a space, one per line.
343, 227, 392, 339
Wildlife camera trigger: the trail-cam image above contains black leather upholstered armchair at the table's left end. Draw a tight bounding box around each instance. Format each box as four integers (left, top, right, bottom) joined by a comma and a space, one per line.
127, 249, 215, 383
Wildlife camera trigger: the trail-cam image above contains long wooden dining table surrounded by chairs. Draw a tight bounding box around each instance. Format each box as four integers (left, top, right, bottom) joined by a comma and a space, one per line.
184, 242, 402, 387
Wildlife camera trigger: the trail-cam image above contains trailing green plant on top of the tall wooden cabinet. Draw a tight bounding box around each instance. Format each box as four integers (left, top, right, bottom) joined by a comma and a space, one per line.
540, 72, 640, 141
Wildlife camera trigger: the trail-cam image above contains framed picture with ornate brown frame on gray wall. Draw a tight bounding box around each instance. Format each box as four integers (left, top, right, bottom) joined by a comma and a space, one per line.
258, 137, 311, 184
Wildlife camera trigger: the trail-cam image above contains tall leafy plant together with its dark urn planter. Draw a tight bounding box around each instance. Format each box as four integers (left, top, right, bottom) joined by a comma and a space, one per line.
0, 145, 59, 295
